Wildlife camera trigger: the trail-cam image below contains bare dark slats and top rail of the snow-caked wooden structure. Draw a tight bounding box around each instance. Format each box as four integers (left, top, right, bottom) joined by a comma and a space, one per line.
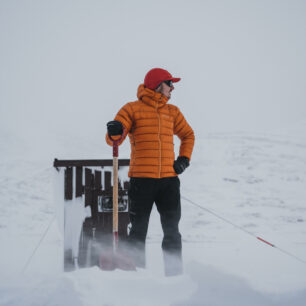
54, 159, 130, 271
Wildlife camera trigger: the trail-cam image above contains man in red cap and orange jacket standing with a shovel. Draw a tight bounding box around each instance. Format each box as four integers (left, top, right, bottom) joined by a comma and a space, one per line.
106, 68, 194, 276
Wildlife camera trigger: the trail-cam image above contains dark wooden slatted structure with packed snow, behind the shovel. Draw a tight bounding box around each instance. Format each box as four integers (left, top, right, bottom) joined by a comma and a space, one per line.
53, 159, 129, 271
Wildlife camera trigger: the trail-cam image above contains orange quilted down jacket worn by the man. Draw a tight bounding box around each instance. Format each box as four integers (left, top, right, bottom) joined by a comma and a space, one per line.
106, 84, 194, 178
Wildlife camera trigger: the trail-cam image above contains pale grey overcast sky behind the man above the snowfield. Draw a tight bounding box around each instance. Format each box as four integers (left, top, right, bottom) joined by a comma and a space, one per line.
0, 0, 306, 158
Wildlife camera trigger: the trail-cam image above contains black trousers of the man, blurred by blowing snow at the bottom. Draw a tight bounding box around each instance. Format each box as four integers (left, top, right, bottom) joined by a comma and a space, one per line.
128, 177, 182, 275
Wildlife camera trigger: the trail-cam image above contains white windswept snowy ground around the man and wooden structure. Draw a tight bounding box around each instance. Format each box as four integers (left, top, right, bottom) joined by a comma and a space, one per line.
0, 129, 306, 306
